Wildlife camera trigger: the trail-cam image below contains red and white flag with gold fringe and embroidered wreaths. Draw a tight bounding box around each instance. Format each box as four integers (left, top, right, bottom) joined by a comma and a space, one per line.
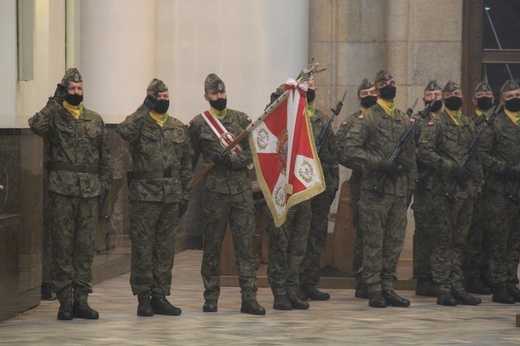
249, 78, 325, 227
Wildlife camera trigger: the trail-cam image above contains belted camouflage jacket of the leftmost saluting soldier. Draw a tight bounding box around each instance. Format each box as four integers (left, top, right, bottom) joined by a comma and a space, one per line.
29, 98, 112, 197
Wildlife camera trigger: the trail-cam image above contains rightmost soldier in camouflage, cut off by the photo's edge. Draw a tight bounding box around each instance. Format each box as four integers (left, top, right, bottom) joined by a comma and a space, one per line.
482, 80, 520, 304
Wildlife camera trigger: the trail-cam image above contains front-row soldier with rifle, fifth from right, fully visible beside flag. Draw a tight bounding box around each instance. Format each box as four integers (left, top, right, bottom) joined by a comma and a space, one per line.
345, 70, 417, 308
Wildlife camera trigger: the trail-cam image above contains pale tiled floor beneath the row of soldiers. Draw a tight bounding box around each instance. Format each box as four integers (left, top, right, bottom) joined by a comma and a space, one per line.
0, 250, 520, 346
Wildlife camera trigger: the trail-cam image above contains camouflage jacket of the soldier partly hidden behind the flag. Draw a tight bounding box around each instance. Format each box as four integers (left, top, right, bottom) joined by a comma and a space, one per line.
310, 109, 339, 190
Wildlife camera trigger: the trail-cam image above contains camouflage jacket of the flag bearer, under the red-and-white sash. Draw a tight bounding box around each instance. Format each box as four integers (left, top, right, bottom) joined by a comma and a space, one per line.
188, 108, 253, 195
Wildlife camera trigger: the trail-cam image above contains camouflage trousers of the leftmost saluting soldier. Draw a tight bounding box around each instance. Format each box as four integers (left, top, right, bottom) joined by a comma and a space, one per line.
49, 191, 99, 302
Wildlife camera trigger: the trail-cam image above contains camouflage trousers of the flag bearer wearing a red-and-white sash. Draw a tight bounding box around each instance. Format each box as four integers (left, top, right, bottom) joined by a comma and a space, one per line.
200, 190, 257, 301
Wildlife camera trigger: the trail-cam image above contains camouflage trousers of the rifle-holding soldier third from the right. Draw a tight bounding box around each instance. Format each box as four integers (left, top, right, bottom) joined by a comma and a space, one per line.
431, 194, 474, 291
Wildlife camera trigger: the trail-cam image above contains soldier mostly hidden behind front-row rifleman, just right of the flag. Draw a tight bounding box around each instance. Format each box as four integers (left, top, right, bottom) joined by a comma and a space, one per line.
336, 78, 377, 299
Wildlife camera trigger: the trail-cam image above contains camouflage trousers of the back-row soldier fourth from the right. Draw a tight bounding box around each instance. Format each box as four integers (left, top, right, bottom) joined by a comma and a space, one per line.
412, 187, 434, 280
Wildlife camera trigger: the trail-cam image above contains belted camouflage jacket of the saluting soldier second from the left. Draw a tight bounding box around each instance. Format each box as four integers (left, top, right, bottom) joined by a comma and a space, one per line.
117, 105, 193, 203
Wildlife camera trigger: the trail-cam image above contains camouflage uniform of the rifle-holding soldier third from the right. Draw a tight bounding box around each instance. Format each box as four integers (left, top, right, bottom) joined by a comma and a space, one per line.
418, 85, 483, 296
